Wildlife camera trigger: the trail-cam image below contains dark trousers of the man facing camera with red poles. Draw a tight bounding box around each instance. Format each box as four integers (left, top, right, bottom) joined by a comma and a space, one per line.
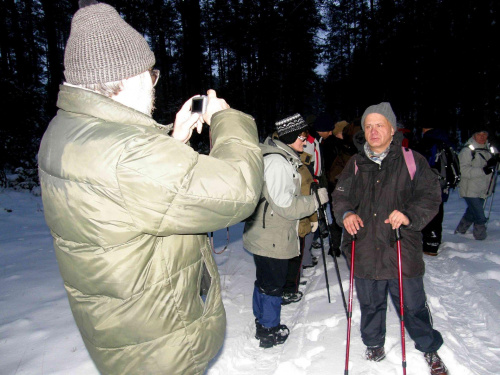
356, 277, 443, 353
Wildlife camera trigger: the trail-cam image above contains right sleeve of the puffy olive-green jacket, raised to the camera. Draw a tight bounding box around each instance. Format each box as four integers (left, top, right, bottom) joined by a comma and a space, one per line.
117, 109, 263, 235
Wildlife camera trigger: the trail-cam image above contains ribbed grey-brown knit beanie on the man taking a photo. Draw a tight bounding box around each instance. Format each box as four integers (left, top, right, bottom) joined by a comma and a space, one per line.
64, 1, 155, 85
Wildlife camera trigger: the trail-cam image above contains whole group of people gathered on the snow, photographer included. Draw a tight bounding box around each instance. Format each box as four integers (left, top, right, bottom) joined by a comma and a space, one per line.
38, 0, 499, 375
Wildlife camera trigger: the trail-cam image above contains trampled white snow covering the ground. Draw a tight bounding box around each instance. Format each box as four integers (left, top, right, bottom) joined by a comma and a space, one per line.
0, 190, 500, 375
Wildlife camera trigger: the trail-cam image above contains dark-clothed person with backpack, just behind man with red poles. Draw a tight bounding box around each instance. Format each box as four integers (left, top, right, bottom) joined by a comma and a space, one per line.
415, 127, 460, 256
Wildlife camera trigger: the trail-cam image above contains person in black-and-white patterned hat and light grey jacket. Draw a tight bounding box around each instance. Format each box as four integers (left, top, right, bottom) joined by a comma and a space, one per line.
243, 114, 328, 348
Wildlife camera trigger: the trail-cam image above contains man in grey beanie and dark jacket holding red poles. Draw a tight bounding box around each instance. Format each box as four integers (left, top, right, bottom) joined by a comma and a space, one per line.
332, 102, 447, 375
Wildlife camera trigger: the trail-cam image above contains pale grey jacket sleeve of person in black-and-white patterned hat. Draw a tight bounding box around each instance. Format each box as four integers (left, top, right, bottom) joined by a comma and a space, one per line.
264, 155, 316, 220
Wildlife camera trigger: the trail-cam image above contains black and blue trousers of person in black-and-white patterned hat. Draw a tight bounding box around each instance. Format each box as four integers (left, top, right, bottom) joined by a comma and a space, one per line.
252, 254, 288, 328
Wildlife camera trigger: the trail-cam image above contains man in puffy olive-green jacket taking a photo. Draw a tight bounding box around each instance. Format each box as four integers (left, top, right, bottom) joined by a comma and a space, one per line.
38, 1, 263, 375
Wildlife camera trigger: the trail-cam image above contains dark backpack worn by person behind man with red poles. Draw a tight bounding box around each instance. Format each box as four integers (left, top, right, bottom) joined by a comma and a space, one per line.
428, 143, 460, 190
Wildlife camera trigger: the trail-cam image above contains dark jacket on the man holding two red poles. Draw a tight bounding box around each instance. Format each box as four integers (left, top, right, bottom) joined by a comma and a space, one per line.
333, 132, 441, 280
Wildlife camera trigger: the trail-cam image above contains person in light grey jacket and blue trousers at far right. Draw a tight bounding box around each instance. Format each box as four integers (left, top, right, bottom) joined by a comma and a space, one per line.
455, 130, 499, 240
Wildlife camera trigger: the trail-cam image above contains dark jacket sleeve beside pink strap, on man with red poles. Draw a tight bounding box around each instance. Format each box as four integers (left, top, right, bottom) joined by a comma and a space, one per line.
401, 152, 441, 231
